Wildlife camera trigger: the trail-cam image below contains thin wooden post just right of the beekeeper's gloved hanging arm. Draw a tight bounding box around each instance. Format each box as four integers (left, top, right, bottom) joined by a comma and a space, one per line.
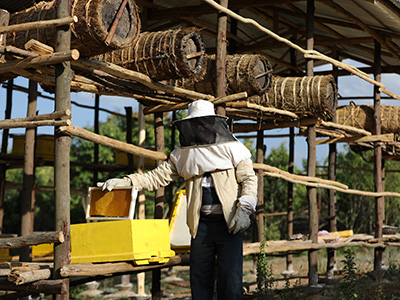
256, 130, 265, 242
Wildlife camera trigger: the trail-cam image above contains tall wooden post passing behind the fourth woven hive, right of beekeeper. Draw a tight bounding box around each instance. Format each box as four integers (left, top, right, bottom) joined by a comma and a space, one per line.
306, 0, 319, 286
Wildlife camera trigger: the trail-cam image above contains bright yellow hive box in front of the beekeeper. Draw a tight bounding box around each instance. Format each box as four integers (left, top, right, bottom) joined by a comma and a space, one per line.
71, 219, 175, 265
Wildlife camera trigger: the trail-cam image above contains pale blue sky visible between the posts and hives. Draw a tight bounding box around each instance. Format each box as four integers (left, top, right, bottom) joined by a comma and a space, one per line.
0, 61, 400, 168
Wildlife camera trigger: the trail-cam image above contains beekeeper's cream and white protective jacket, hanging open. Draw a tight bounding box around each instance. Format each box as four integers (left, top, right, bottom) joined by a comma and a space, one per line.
127, 141, 257, 237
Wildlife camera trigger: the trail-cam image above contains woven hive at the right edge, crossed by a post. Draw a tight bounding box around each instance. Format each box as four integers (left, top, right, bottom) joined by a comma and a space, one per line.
336, 105, 400, 135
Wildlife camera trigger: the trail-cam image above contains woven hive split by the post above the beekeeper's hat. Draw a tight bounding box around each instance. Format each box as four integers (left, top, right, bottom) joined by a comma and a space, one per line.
171, 54, 272, 95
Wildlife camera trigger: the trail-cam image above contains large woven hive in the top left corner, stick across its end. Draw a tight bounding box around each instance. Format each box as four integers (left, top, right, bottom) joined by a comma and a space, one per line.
7, 0, 140, 57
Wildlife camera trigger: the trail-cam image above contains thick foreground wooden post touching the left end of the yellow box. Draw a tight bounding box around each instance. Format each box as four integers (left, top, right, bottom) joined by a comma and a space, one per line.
53, 0, 72, 300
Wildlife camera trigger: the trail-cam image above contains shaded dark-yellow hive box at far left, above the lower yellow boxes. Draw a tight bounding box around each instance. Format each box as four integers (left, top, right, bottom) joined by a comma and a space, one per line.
11, 135, 54, 161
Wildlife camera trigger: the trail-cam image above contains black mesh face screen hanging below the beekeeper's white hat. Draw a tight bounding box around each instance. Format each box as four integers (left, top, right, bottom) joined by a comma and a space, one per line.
175, 116, 236, 147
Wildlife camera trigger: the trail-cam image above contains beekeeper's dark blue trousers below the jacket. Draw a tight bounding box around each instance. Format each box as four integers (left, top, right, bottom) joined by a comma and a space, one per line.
190, 216, 243, 300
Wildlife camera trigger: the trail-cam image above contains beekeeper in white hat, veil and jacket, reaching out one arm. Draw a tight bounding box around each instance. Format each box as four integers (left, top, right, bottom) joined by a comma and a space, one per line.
100, 100, 257, 300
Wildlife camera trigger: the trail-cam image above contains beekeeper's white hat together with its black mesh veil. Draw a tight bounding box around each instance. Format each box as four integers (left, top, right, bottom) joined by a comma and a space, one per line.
174, 100, 237, 147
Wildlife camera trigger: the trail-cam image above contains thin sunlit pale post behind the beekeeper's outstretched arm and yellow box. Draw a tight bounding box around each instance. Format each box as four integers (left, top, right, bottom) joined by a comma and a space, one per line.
136, 102, 147, 296
